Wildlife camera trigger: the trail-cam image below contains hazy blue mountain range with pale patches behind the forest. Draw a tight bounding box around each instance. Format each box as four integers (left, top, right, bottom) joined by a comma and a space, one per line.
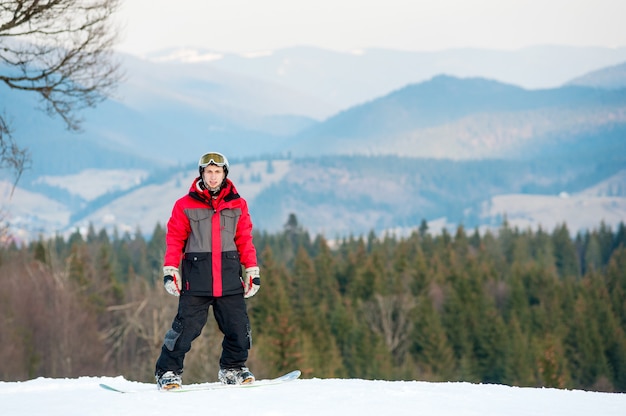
0, 47, 626, 239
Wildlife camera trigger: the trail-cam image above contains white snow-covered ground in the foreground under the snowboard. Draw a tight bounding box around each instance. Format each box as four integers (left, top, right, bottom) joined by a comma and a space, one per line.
0, 377, 626, 416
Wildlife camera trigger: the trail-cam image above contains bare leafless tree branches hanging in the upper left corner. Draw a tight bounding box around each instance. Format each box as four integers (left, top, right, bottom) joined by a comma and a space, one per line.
0, 0, 121, 179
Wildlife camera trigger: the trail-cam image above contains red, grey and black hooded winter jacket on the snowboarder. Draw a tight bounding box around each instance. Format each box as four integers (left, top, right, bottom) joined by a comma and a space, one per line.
164, 177, 257, 297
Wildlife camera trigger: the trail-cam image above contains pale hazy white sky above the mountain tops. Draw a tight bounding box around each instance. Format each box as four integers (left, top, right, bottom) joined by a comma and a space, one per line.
118, 0, 626, 55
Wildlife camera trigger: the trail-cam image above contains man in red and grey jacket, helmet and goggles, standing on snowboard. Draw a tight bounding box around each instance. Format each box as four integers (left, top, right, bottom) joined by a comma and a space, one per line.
155, 152, 261, 390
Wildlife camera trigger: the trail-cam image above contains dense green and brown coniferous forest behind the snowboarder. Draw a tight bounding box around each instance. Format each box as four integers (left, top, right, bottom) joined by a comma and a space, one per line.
0, 219, 626, 392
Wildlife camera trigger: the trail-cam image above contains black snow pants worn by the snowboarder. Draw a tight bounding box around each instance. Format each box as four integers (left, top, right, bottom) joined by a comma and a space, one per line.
155, 294, 252, 375
